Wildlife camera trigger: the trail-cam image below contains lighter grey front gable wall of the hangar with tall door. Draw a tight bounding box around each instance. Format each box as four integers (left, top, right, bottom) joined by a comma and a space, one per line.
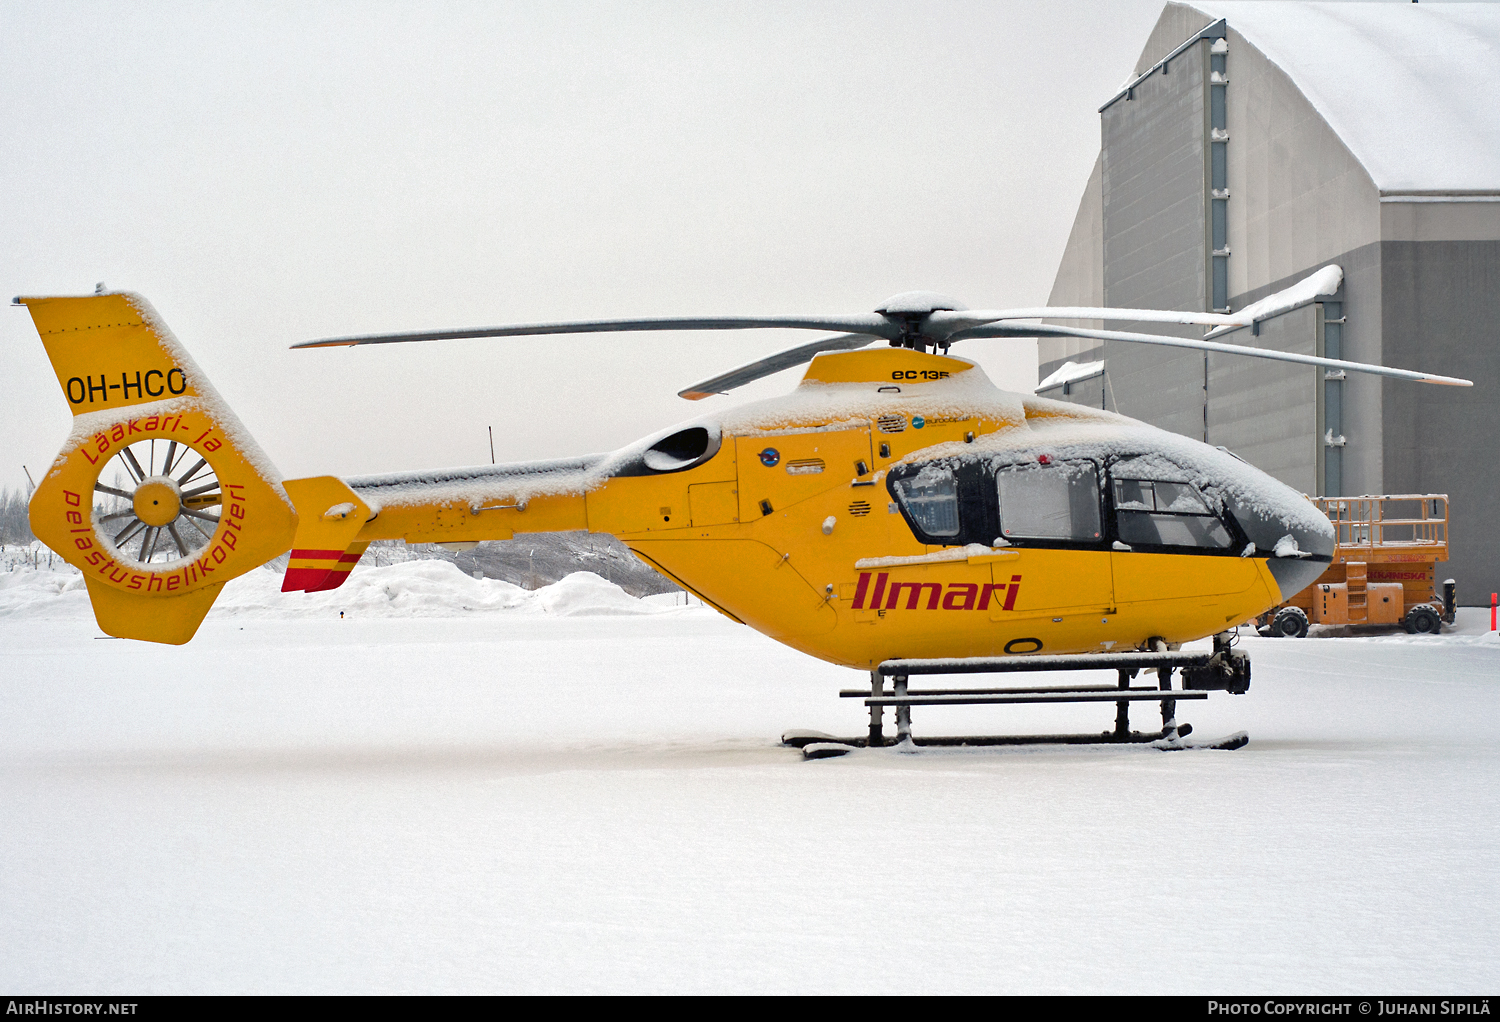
1040, 3, 1374, 494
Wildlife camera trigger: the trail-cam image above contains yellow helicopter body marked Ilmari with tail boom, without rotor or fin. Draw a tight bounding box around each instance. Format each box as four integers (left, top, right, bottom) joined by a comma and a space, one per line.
310, 348, 1334, 668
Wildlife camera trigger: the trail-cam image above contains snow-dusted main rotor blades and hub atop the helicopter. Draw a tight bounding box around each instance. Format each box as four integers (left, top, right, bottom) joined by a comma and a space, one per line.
293, 266, 1473, 401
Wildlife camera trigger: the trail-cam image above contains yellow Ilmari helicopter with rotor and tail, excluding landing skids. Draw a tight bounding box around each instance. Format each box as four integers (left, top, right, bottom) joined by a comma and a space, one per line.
15, 267, 1470, 744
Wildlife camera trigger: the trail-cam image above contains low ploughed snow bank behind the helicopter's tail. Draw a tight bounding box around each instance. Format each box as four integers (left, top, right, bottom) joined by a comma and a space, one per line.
0, 561, 713, 620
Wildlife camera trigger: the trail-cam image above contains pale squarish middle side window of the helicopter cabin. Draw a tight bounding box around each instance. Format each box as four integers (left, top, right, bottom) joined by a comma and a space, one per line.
995, 461, 1100, 543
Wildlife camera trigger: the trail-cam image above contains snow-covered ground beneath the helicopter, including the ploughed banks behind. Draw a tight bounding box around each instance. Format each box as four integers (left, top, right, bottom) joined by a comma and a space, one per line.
0, 563, 1500, 993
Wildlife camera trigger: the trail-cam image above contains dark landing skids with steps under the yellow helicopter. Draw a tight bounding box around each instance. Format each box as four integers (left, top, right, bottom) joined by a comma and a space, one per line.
782, 633, 1250, 759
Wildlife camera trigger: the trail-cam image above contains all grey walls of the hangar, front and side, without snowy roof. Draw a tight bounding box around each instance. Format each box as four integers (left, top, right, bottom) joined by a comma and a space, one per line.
1040, 3, 1500, 605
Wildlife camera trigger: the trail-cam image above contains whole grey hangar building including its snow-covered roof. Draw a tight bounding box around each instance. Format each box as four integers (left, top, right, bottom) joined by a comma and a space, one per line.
1038, 0, 1500, 603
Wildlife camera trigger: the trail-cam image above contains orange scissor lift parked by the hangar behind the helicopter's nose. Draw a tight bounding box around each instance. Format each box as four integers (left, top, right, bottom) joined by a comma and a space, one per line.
1256, 494, 1455, 638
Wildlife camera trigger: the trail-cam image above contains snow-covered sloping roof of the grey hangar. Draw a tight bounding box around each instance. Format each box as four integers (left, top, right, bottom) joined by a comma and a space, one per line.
1191, 0, 1500, 192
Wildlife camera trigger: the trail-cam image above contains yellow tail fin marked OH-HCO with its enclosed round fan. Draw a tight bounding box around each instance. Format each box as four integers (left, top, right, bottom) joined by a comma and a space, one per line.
17, 293, 297, 644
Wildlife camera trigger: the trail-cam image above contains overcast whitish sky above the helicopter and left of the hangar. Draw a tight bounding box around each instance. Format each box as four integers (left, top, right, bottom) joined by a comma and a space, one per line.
0, 0, 1163, 486
